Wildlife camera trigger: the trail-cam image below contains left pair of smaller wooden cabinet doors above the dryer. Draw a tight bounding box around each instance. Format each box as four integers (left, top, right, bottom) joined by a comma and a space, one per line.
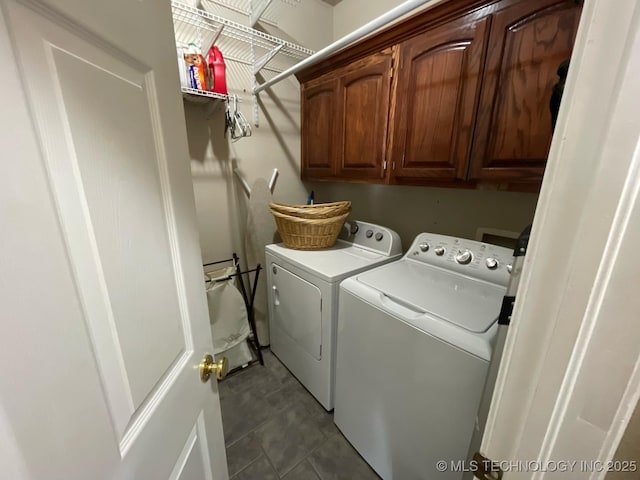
302, 49, 392, 182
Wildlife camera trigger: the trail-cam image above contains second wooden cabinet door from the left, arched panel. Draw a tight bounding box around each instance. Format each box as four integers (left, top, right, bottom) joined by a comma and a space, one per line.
336, 52, 392, 181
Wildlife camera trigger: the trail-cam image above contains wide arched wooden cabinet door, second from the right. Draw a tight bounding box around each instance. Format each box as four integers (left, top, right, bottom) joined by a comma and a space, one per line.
393, 19, 488, 183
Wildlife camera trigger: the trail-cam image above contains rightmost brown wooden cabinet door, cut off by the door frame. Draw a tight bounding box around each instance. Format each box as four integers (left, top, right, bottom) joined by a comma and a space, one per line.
470, 0, 581, 182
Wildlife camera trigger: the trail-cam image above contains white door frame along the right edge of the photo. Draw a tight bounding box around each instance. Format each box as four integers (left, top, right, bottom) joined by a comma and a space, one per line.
481, 0, 640, 479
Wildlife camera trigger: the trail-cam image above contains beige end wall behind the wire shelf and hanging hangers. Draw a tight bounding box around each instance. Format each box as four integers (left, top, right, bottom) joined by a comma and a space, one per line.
185, 0, 333, 262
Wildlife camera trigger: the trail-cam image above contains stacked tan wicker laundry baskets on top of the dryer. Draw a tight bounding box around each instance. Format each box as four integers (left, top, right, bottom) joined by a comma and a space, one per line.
270, 202, 351, 250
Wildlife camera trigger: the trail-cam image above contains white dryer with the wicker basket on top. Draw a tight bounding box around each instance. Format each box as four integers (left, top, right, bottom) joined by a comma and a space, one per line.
266, 222, 402, 410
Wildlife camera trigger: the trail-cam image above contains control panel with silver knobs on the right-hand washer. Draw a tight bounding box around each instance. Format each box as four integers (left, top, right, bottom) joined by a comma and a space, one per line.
405, 233, 513, 286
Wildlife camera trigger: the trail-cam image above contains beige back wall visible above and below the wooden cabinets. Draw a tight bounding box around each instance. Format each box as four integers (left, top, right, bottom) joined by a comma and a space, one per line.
318, 0, 538, 249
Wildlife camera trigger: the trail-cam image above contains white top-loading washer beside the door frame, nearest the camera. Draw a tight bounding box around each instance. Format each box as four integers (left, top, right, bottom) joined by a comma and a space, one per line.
334, 233, 513, 480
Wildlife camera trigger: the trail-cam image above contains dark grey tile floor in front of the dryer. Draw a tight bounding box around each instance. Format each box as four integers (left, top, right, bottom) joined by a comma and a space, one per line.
219, 350, 380, 480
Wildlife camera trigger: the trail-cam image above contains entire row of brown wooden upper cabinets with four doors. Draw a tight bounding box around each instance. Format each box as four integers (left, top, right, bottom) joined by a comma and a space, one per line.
298, 0, 582, 191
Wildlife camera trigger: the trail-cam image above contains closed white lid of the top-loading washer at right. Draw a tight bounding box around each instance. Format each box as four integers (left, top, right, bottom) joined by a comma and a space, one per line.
357, 259, 506, 333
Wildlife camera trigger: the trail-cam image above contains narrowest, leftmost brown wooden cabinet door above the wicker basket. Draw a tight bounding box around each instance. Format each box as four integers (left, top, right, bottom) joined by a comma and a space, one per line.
301, 77, 338, 180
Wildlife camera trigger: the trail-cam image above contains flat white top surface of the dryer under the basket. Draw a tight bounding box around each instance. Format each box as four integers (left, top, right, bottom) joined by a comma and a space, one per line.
266, 240, 399, 282
